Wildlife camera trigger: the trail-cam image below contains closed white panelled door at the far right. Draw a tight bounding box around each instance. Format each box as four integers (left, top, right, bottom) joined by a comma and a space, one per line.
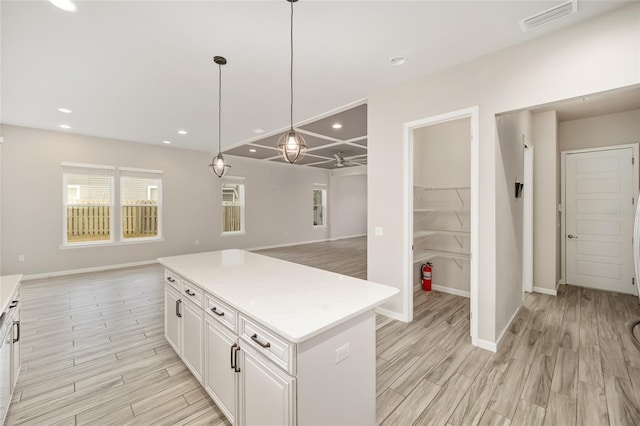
564, 147, 635, 294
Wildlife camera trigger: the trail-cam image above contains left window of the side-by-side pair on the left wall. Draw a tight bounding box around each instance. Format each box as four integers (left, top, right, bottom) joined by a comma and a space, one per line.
62, 164, 114, 244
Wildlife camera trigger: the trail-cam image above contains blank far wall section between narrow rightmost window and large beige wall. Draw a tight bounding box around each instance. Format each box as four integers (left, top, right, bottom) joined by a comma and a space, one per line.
329, 167, 367, 240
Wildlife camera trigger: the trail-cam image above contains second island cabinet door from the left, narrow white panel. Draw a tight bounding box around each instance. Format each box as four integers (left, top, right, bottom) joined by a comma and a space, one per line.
181, 302, 204, 383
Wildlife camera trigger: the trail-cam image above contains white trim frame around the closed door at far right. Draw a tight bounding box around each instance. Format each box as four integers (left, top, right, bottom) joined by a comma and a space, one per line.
559, 143, 640, 294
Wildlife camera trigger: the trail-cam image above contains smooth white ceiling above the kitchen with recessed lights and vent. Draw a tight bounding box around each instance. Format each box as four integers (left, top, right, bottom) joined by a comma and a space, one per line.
0, 0, 629, 152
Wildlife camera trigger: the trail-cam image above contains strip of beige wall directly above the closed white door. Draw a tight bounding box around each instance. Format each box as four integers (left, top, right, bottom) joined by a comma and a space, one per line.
558, 109, 640, 151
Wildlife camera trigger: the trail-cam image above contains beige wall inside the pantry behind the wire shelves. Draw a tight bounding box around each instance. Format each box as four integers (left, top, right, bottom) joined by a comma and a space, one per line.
413, 118, 471, 295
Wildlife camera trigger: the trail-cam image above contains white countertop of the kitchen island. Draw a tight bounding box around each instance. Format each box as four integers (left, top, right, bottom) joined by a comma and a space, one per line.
158, 249, 398, 343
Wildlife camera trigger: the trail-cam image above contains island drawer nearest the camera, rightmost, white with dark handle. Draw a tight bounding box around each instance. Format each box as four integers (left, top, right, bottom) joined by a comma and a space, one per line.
239, 314, 296, 375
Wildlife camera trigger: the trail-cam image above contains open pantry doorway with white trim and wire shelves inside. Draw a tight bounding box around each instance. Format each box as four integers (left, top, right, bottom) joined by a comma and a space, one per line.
405, 107, 479, 346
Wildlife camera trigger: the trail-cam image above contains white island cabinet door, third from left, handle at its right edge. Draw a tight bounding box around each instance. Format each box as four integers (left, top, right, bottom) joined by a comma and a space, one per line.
204, 318, 238, 424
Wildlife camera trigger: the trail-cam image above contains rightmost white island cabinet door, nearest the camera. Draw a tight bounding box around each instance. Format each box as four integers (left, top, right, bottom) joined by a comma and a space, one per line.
239, 347, 295, 426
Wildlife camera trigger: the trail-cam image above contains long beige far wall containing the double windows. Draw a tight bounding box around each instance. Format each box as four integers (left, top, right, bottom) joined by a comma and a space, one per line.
1, 125, 329, 274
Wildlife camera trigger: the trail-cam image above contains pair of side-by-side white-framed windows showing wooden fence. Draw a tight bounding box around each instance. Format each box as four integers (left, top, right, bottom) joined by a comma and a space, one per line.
62, 163, 162, 246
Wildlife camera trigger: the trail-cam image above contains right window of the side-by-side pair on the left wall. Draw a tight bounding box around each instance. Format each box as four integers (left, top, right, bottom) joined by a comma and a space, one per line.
120, 168, 162, 241
